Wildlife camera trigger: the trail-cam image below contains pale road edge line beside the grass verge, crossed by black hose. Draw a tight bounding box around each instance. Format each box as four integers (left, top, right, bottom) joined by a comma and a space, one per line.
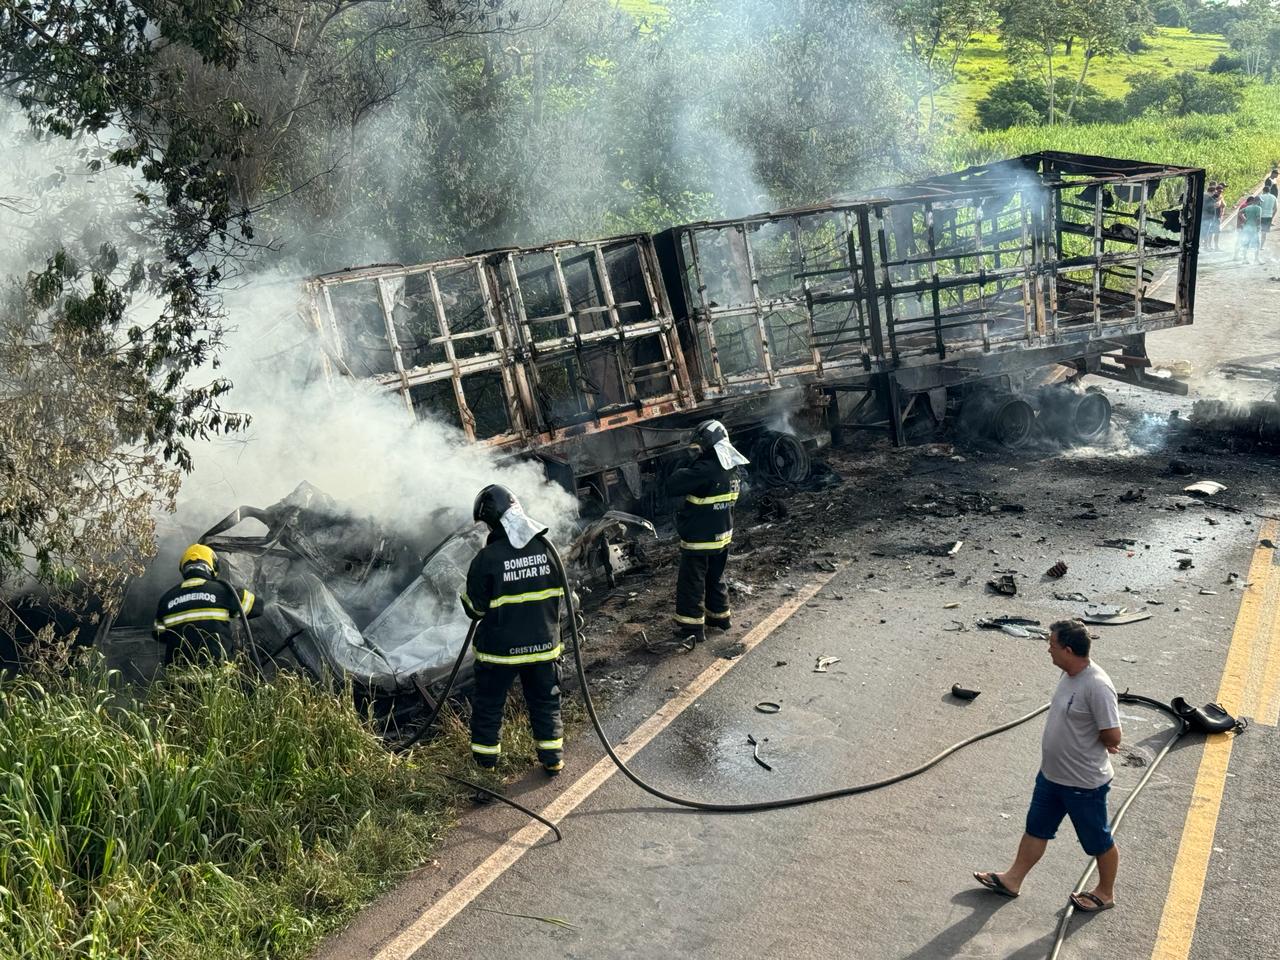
372, 573, 835, 960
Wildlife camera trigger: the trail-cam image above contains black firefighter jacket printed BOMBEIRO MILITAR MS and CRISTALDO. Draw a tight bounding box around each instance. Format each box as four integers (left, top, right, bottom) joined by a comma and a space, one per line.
462, 531, 564, 666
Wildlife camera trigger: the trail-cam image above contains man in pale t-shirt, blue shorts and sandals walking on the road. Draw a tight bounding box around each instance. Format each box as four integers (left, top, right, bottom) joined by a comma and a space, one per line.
973, 620, 1120, 914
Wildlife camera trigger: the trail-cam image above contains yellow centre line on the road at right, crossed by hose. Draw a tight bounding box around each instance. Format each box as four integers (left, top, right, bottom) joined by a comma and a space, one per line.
1151, 520, 1277, 960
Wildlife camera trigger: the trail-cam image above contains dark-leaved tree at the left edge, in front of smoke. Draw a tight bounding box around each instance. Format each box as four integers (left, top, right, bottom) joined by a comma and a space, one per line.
0, 0, 253, 604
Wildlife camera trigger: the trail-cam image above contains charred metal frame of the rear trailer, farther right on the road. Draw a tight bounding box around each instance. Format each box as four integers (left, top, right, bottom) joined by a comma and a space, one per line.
657, 152, 1204, 443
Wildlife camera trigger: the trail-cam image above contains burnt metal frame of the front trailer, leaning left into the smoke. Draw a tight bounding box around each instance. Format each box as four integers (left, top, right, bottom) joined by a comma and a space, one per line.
307, 234, 692, 448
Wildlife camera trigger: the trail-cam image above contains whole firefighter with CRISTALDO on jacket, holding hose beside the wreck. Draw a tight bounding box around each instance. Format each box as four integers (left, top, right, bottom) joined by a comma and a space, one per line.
462, 484, 564, 777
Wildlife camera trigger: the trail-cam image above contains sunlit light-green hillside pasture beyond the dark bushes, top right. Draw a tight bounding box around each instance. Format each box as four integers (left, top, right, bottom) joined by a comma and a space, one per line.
925, 27, 1228, 127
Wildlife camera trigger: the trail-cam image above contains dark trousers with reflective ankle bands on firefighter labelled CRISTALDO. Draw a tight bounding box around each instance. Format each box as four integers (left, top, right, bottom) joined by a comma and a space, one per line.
471, 660, 564, 771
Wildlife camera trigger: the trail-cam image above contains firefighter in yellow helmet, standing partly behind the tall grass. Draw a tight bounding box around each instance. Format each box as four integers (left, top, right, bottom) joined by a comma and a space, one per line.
152, 543, 262, 664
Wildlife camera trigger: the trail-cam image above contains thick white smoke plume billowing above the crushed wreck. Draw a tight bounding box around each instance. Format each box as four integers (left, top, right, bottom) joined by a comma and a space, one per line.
179, 275, 576, 547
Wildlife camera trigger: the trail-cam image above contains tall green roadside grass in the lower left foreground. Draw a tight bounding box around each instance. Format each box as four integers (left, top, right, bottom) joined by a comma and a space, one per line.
0, 664, 486, 960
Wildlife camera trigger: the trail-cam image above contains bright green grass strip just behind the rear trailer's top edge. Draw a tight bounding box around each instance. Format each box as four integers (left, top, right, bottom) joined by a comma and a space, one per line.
937, 83, 1280, 202
